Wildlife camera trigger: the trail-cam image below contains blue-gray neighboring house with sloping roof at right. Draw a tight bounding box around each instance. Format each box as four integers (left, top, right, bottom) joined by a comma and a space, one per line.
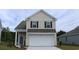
58, 26, 79, 45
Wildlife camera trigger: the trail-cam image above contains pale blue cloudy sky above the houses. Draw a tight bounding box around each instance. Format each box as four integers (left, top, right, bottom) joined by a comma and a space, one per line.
0, 9, 79, 32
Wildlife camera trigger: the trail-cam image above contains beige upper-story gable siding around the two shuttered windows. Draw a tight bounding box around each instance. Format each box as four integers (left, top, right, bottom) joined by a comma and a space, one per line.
26, 12, 56, 29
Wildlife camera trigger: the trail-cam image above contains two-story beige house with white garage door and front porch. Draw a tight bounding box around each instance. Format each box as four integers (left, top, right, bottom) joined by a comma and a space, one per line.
15, 10, 57, 48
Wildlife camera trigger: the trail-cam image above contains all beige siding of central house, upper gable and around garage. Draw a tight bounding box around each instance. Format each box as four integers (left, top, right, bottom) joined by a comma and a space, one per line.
26, 12, 57, 46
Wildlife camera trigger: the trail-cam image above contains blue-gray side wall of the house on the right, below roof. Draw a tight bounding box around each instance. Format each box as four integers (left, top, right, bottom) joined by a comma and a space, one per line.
59, 35, 79, 45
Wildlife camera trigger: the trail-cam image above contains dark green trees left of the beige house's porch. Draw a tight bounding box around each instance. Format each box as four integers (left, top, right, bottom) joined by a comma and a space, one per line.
1, 27, 14, 46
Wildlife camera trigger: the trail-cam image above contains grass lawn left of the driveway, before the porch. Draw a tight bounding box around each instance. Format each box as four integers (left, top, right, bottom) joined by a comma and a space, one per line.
0, 42, 24, 50
